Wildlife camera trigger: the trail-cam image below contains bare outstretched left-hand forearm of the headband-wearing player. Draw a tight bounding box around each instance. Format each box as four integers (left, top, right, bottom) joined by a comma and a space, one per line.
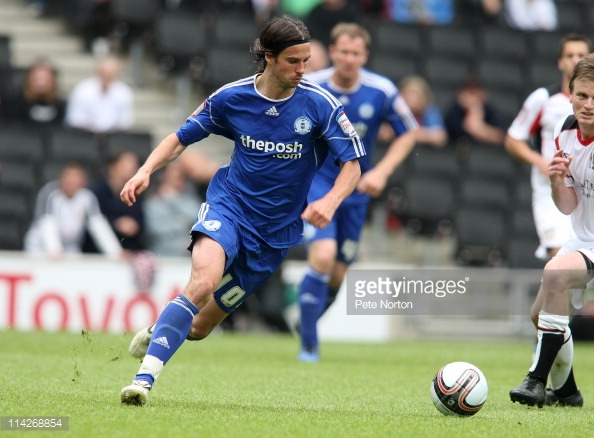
120, 134, 186, 206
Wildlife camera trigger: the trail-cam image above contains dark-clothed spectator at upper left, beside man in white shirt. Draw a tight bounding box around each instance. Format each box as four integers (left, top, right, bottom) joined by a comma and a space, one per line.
4, 60, 66, 126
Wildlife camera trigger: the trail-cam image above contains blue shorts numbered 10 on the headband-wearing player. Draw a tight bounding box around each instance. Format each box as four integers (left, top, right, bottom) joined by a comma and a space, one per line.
188, 202, 287, 313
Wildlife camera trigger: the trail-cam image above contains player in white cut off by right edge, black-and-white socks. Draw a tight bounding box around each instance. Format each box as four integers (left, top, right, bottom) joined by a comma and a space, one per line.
510, 54, 594, 407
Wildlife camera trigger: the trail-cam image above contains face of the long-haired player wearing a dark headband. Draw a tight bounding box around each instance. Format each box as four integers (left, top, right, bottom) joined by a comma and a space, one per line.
267, 43, 311, 89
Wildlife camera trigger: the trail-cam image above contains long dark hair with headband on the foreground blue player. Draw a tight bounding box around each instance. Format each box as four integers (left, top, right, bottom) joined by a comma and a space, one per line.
251, 15, 309, 73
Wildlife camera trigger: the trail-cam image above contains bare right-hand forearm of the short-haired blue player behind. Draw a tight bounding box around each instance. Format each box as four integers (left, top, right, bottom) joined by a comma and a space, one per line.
357, 130, 416, 196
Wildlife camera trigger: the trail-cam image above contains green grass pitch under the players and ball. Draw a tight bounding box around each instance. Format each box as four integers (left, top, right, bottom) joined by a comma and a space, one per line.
0, 331, 594, 438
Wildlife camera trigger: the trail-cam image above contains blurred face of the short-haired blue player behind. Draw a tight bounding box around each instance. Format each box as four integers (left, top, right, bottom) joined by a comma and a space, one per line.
330, 35, 369, 82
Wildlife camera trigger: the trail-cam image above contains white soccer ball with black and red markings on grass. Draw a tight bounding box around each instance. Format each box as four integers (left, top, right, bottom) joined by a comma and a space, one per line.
431, 362, 489, 417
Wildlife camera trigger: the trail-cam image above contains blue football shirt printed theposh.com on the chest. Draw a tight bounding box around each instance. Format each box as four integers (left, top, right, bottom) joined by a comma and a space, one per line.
177, 75, 366, 247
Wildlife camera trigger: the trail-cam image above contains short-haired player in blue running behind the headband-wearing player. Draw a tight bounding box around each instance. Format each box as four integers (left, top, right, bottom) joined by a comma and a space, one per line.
298, 23, 418, 363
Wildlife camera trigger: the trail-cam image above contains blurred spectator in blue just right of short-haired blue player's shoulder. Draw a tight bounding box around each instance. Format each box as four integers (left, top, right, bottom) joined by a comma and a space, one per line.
396, 75, 448, 147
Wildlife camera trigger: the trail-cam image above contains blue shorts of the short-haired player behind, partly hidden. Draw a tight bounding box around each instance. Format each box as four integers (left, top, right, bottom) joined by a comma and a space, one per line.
303, 181, 369, 265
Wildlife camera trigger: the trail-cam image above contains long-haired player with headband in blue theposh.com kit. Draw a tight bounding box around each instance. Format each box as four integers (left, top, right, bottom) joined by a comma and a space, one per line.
120, 16, 365, 405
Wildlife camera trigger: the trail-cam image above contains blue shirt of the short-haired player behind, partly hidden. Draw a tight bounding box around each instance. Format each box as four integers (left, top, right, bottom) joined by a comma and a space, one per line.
307, 67, 418, 200
